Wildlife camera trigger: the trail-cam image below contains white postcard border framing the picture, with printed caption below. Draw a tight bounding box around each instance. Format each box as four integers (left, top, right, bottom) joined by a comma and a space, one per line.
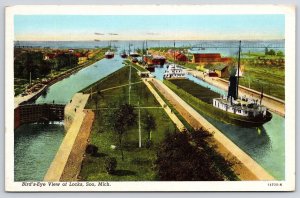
5, 5, 295, 191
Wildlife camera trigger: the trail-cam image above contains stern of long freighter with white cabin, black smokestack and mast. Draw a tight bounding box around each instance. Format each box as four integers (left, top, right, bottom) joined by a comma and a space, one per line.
213, 41, 272, 127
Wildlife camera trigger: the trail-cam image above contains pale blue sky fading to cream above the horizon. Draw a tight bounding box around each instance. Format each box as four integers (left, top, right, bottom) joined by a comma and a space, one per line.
14, 15, 285, 40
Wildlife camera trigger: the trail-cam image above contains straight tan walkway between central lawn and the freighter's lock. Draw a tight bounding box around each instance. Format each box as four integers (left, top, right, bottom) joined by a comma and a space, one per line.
152, 79, 275, 180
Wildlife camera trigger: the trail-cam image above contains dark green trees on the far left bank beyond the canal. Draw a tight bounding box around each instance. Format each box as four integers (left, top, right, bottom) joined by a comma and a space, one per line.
14, 51, 78, 79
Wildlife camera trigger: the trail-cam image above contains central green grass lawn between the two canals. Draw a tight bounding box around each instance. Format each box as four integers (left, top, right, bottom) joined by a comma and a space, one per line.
80, 67, 177, 181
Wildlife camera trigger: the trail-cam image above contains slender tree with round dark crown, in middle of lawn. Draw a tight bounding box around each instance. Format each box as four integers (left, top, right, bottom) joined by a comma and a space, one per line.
108, 103, 137, 160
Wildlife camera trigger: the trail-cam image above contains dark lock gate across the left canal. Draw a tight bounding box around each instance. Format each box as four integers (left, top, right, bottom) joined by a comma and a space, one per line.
14, 104, 65, 129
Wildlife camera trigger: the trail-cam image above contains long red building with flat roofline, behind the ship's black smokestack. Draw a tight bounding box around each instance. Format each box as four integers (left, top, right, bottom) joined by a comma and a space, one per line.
192, 53, 232, 64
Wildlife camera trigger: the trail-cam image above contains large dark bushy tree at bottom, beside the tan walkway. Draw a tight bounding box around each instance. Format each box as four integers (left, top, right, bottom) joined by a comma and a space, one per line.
155, 130, 237, 181
